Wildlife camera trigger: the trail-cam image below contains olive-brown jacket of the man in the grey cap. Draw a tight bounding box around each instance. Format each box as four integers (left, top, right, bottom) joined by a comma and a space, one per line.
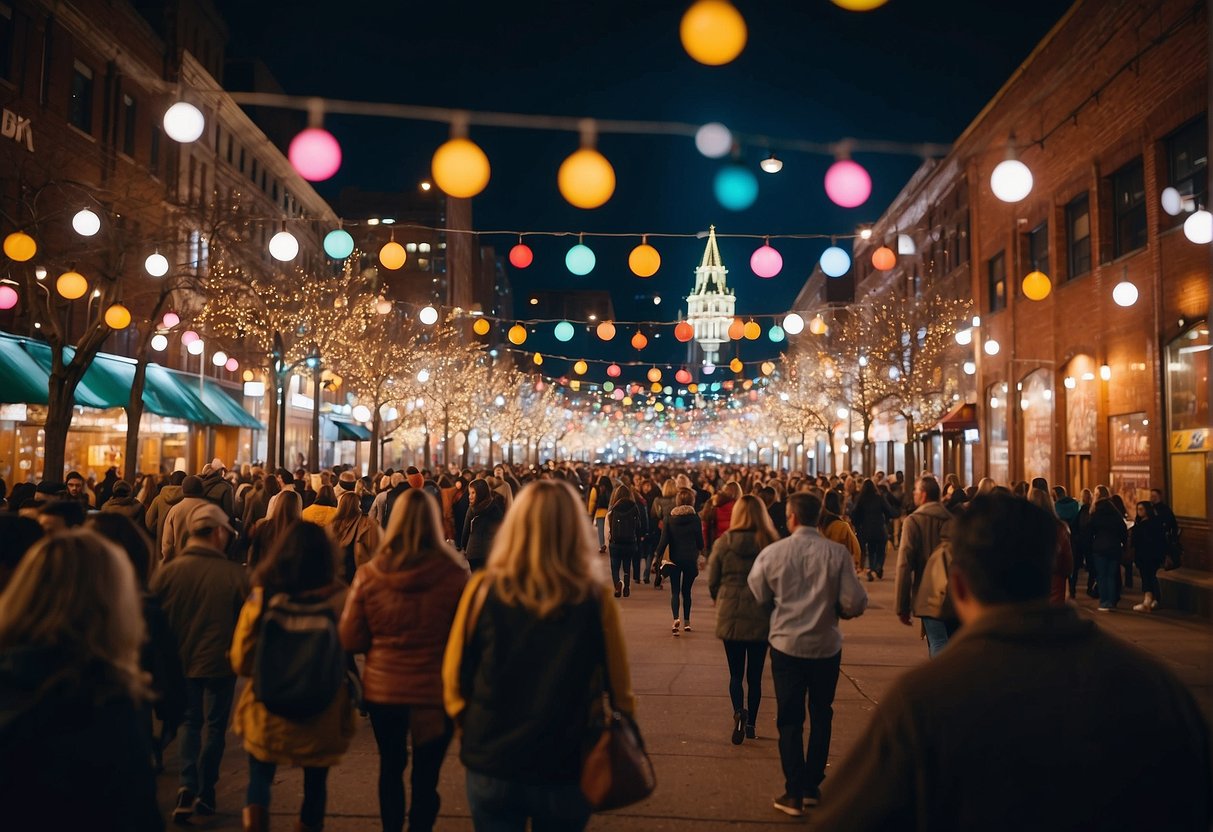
152, 540, 249, 679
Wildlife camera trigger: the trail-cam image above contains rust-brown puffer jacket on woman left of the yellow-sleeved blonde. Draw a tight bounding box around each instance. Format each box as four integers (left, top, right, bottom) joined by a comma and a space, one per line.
341, 554, 467, 707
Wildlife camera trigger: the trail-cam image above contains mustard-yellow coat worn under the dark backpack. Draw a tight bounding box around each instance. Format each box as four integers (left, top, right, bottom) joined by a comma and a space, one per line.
228, 583, 354, 768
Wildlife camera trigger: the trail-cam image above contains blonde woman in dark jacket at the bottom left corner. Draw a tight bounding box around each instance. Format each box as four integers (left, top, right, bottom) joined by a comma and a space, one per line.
0, 530, 164, 831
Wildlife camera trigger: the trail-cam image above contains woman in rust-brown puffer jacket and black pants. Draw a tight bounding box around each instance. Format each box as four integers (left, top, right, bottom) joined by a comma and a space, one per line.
341, 490, 467, 832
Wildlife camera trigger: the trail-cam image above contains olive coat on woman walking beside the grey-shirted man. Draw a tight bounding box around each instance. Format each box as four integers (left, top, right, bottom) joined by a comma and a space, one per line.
707, 531, 771, 642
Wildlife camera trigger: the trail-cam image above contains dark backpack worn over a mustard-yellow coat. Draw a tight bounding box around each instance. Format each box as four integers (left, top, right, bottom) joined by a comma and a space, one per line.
252, 594, 346, 720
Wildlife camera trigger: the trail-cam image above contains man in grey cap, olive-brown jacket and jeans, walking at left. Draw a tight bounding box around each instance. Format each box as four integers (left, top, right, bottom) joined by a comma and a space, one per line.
150, 500, 249, 822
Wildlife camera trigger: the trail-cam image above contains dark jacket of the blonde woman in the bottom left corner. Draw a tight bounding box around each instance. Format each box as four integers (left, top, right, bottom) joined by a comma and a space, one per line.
0, 646, 164, 832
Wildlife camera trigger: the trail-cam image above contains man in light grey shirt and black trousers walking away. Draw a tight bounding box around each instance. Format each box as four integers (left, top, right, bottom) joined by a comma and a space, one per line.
746, 492, 867, 817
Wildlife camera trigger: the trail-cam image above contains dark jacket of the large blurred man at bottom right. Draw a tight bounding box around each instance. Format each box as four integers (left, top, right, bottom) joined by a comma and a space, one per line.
813, 600, 1213, 832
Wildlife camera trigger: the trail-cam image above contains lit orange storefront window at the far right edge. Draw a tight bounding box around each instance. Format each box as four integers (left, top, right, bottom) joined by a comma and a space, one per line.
1167, 323, 1213, 518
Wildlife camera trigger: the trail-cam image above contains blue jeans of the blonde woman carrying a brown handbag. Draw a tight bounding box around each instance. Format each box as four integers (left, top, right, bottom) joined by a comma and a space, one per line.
467, 771, 591, 832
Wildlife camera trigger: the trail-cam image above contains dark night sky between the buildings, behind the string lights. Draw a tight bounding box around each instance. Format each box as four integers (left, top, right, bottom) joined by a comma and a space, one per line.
218, 0, 1069, 375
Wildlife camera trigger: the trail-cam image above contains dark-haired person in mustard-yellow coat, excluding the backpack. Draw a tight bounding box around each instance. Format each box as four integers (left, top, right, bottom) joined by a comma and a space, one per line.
229, 523, 354, 832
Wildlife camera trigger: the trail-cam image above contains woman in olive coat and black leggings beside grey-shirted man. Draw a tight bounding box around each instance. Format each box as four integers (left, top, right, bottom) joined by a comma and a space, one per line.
707, 494, 779, 746
